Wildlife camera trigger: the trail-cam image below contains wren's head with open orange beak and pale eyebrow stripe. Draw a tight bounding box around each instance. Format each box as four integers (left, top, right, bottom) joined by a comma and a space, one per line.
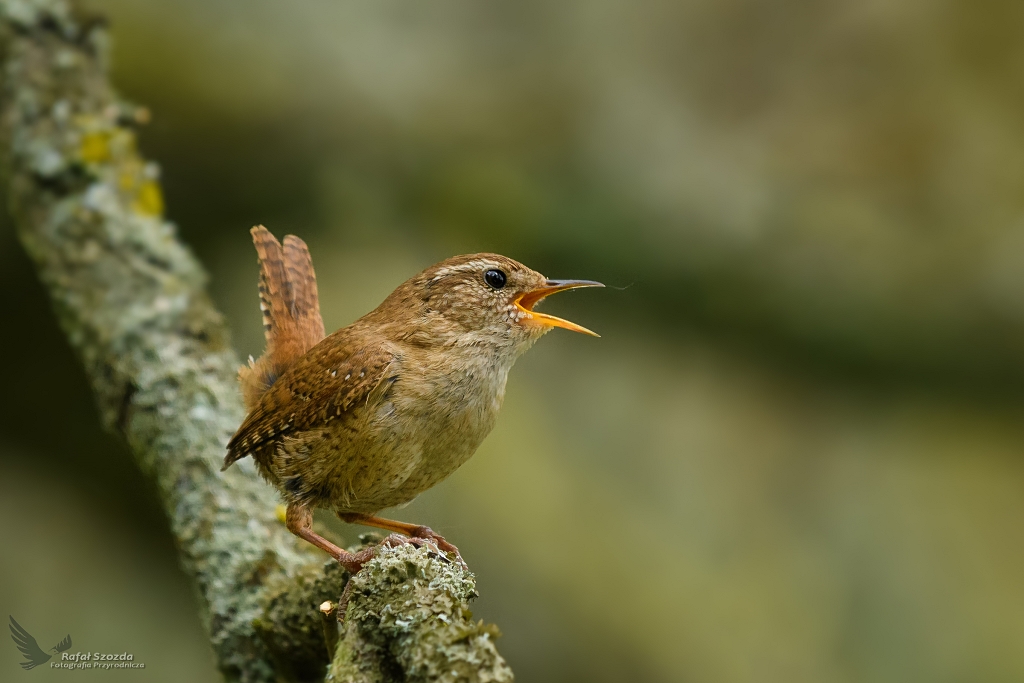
379, 254, 604, 355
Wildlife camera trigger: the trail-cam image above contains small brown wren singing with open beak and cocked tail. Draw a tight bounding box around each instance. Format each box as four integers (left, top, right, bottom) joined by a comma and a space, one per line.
224, 225, 603, 571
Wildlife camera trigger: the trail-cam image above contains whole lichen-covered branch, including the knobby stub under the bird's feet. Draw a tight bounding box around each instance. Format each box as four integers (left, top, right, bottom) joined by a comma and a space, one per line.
0, 0, 511, 681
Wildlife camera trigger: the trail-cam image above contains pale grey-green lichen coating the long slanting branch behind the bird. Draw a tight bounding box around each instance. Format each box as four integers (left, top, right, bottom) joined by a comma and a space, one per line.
0, 0, 340, 681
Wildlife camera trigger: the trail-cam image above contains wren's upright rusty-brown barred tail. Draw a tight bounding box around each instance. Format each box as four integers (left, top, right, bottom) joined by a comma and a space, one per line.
239, 225, 324, 411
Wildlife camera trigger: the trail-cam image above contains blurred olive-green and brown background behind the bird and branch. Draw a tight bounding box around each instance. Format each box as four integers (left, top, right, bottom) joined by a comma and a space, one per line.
0, 0, 1024, 683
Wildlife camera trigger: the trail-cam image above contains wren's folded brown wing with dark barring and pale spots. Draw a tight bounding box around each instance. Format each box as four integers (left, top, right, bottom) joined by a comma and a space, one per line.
224, 330, 398, 469
